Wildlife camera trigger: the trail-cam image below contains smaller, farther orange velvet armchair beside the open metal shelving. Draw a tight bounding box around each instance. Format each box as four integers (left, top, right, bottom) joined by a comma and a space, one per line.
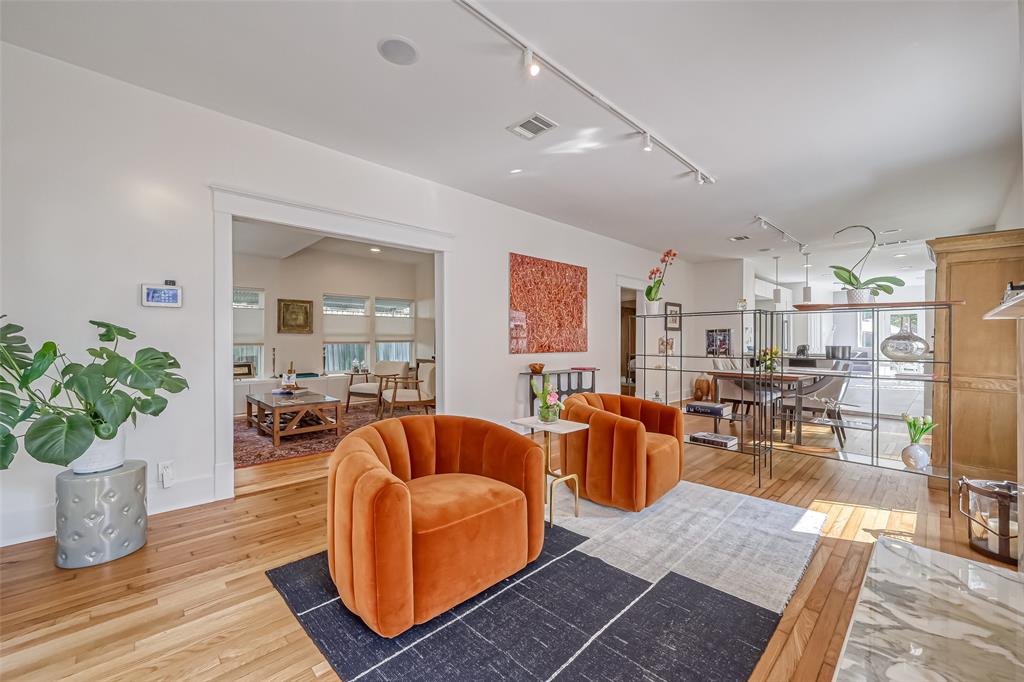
561, 393, 683, 511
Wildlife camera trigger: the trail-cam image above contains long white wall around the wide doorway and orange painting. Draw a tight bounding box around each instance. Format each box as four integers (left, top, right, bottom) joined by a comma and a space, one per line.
0, 44, 663, 544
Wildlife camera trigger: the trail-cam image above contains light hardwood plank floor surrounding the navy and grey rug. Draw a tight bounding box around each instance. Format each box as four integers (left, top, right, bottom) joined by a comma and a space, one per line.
0, 432, 999, 682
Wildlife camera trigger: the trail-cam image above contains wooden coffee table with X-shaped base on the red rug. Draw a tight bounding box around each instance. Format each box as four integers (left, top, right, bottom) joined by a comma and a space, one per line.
246, 392, 341, 446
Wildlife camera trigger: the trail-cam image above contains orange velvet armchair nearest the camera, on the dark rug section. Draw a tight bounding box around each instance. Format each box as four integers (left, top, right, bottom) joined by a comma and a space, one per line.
327, 415, 544, 637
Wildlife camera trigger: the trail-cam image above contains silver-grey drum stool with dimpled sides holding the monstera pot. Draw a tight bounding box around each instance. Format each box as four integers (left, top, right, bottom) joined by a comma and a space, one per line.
53, 458, 148, 568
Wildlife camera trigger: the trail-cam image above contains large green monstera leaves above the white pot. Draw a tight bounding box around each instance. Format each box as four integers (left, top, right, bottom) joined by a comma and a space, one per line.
0, 315, 188, 469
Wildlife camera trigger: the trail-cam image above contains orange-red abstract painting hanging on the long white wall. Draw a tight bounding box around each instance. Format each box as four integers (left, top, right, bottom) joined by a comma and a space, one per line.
509, 253, 587, 353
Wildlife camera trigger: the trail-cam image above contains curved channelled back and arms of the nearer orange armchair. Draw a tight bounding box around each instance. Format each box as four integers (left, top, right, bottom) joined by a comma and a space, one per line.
328, 415, 544, 636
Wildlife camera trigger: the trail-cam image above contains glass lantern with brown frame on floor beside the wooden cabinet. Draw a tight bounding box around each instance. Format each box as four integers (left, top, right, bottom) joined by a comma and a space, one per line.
956, 476, 1020, 565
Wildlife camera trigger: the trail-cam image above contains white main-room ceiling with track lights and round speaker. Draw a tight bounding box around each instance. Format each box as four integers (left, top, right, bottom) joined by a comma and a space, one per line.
2, 0, 1021, 281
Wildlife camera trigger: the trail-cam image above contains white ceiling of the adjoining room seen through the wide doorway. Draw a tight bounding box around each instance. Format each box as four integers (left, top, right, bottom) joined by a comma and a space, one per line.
231, 218, 433, 265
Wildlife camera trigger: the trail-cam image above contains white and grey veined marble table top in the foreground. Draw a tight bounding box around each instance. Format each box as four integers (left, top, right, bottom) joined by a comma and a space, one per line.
834, 536, 1024, 682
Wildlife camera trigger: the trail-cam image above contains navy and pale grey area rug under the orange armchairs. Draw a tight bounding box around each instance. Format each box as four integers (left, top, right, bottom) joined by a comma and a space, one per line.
267, 481, 825, 682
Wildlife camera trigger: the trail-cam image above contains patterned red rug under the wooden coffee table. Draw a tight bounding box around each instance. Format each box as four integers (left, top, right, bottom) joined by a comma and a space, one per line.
234, 403, 377, 469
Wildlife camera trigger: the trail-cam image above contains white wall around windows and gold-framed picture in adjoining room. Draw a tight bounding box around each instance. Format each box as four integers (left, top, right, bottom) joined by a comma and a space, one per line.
232, 249, 434, 376
